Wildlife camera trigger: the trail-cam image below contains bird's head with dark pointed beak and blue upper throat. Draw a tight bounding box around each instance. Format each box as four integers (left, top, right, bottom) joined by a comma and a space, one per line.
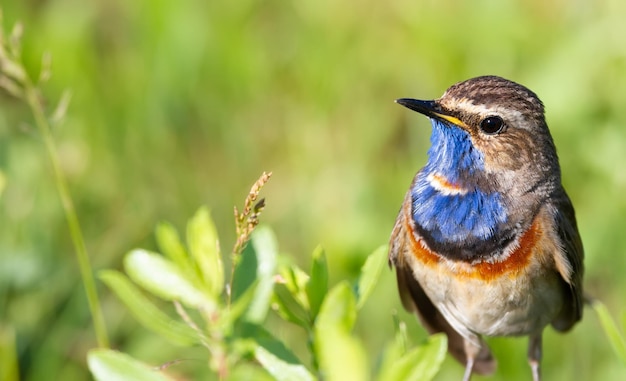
396, 76, 560, 199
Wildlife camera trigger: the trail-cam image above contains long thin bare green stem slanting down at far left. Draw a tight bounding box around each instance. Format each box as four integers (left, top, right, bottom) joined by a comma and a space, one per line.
23, 79, 109, 348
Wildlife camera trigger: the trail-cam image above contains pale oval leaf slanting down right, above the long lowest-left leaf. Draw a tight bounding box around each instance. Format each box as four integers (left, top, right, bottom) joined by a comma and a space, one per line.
124, 249, 216, 312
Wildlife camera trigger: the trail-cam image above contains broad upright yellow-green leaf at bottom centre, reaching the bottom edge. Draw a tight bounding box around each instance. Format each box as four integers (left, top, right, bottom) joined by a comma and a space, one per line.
314, 282, 369, 381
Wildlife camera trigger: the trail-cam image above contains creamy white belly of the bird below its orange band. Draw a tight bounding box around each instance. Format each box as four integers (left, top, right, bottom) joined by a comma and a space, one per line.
413, 249, 563, 338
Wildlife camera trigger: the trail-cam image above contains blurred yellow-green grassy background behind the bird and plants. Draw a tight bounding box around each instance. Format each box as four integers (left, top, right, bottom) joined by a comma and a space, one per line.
0, 0, 626, 380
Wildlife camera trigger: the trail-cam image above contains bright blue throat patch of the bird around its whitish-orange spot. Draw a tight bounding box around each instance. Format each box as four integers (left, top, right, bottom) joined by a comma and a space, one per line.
411, 119, 507, 244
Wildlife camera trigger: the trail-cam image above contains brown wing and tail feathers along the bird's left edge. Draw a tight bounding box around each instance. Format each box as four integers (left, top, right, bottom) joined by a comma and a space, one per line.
389, 190, 496, 375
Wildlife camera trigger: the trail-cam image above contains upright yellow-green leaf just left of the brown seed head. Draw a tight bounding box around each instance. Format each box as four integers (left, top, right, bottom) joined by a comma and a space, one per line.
187, 208, 224, 299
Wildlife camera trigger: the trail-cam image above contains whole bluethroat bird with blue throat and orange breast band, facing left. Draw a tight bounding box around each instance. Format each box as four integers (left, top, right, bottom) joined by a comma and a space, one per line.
389, 76, 583, 381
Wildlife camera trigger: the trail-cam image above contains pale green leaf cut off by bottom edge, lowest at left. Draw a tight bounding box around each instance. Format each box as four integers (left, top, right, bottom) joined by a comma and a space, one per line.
87, 349, 174, 381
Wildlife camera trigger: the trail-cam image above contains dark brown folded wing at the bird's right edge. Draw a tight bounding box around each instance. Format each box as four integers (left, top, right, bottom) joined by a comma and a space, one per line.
552, 191, 584, 331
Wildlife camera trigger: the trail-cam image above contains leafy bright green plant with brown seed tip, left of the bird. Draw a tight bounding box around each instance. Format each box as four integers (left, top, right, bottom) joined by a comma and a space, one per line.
88, 174, 446, 381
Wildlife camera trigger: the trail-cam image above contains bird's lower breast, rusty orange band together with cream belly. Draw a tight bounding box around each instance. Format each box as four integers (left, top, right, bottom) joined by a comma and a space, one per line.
405, 208, 563, 337
